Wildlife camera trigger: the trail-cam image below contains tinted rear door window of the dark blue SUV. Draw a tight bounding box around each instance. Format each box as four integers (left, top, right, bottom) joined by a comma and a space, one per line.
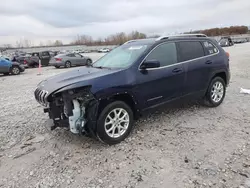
178, 41, 205, 62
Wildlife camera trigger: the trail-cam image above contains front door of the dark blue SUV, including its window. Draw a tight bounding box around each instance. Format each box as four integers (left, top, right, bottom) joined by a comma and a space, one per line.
136, 42, 185, 108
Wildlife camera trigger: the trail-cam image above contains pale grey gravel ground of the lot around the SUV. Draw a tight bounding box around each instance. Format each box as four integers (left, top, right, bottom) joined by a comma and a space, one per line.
0, 46, 250, 188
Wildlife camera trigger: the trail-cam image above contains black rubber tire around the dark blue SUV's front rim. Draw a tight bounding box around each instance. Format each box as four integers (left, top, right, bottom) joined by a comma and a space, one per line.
96, 101, 134, 145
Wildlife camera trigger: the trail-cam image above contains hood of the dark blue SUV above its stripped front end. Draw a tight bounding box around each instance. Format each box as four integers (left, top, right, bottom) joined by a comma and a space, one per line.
37, 67, 120, 94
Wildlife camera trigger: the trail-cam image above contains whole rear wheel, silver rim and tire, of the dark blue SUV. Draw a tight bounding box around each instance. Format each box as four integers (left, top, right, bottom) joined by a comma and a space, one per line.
204, 77, 226, 107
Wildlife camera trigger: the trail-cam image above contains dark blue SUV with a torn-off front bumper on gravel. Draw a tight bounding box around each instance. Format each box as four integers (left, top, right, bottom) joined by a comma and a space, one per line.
35, 34, 230, 144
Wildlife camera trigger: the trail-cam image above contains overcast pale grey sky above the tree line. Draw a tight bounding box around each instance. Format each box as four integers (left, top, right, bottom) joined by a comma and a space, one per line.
0, 0, 250, 45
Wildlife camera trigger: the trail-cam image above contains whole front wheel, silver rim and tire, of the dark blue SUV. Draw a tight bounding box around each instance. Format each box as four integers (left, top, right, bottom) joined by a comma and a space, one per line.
97, 101, 134, 145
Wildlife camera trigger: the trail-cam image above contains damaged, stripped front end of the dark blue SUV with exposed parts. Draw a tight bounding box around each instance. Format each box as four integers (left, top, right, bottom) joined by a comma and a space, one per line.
35, 88, 99, 136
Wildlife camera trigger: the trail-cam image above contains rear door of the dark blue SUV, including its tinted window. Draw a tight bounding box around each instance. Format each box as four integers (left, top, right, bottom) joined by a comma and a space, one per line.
178, 41, 214, 95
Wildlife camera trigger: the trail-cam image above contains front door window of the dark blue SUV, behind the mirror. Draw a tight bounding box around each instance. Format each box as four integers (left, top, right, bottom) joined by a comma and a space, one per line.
146, 43, 178, 67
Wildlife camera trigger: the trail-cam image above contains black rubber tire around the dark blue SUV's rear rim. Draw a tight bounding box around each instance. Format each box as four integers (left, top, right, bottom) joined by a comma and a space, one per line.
203, 77, 226, 107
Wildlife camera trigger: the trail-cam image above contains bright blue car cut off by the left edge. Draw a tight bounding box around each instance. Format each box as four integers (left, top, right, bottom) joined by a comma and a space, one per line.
0, 58, 25, 75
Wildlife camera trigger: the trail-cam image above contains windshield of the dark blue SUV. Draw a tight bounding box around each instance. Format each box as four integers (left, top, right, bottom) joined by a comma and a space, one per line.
93, 44, 148, 68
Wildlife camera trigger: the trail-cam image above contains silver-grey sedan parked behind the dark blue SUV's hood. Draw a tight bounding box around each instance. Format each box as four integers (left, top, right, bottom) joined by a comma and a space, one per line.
49, 53, 92, 68
